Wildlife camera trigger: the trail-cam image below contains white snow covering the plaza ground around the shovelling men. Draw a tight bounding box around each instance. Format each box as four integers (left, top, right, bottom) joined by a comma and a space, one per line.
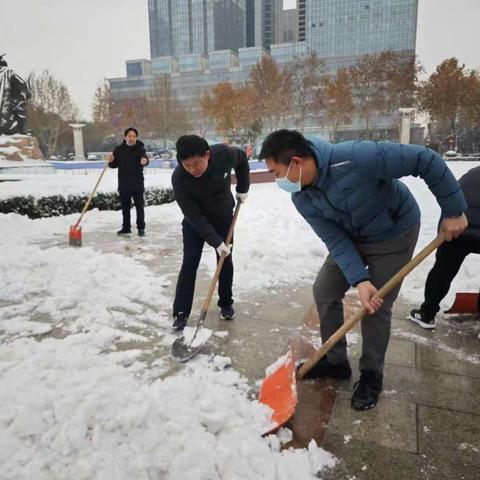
0, 162, 480, 480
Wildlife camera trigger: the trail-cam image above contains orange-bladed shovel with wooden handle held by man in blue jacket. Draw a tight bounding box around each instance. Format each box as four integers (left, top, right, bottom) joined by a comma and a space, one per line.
259, 233, 445, 435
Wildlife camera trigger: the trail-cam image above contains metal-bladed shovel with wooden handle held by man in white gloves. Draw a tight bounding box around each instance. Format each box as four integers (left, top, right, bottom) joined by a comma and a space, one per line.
171, 202, 241, 362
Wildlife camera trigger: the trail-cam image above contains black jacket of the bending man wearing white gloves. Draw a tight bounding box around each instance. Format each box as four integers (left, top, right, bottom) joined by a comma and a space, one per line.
172, 144, 250, 248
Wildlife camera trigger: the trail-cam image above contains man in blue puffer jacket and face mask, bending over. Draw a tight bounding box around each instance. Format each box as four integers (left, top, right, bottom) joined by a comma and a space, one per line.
260, 130, 468, 410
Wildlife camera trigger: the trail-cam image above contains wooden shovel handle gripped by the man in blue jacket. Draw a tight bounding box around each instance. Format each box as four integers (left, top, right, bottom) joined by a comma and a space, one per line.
297, 232, 445, 379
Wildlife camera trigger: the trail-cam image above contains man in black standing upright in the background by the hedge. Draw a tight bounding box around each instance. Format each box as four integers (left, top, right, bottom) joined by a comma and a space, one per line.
107, 127, 148, 237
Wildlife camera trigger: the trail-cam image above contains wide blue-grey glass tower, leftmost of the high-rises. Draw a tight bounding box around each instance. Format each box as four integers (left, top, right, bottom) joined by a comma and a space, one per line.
148, 0, 246, 59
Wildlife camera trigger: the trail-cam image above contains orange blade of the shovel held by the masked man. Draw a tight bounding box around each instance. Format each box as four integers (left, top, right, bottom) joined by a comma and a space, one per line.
259, 349, 297, 435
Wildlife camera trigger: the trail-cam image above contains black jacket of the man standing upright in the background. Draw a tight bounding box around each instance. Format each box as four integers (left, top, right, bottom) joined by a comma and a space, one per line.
109, 140, 148, 193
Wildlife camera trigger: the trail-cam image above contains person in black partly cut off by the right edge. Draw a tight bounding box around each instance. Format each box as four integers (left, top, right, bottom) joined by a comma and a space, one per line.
409, 167, 480, 329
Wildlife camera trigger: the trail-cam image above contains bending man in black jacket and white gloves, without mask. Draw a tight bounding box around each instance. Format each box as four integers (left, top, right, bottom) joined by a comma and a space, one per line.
172, 135, 250, 330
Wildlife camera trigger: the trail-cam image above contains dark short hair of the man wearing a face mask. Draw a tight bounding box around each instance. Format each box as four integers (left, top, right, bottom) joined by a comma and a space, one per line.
259, 129, 313, 165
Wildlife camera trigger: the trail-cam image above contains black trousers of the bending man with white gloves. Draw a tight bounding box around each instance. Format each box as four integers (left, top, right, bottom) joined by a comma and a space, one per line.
173, 216, 233, 316
